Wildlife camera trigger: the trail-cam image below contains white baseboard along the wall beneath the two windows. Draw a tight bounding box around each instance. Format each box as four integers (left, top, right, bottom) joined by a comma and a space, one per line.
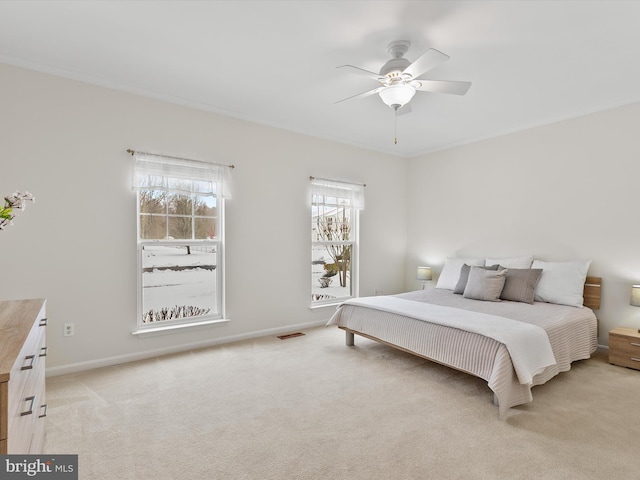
46, 320, 327, 377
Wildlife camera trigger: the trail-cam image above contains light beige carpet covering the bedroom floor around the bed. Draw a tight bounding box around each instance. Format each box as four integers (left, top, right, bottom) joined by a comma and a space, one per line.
46, 327, 640, 480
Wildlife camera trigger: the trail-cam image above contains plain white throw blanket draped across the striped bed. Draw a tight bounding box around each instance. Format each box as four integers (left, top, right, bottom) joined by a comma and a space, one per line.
344, 296, 556, 385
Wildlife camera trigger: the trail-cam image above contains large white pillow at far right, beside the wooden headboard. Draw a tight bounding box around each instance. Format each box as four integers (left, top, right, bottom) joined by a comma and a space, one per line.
532, 260, 591, 308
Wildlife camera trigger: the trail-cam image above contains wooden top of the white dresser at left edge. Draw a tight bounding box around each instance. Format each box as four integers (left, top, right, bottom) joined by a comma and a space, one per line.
0, 298, 45, 381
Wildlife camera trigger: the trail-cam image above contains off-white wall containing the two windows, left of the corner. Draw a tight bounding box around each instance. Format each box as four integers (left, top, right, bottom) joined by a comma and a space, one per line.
0, 65, 407, 373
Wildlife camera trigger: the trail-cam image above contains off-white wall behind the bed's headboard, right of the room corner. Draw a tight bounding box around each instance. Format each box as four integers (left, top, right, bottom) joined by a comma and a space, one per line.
406, 104, 640, 345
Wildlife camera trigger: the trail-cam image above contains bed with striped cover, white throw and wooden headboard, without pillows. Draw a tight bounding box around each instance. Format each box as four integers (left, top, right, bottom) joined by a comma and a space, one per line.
327, 258, 601, 417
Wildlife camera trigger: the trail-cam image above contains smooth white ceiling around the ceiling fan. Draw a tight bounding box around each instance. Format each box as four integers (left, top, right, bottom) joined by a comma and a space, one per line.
0, 0, 640, 157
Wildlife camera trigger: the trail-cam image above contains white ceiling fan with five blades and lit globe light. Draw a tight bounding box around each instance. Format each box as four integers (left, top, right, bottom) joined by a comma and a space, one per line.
336, 40, 471, 114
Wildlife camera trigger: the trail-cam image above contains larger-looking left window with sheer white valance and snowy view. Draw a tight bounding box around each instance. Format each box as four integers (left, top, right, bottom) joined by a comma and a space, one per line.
134, 152, 231, 330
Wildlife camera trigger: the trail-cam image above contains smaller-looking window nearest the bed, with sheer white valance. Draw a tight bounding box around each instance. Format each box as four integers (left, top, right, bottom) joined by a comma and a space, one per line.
311, 177, 364, 306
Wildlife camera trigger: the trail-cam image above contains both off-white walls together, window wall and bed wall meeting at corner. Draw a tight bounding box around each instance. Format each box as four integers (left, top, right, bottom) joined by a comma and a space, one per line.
5, 60, 640, 373
